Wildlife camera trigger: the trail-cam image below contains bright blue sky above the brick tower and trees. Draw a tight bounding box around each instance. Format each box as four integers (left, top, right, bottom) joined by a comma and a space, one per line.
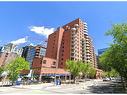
0, 2, 127, 51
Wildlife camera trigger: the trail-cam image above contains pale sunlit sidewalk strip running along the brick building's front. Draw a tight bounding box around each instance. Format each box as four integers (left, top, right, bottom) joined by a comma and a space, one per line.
13, 79, 102, 89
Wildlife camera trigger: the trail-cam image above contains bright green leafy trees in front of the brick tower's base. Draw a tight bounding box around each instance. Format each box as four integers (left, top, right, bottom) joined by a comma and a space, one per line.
66, 60, 96, 82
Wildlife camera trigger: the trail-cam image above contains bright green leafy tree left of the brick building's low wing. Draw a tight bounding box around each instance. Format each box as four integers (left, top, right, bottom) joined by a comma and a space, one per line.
6, 57, 30, 84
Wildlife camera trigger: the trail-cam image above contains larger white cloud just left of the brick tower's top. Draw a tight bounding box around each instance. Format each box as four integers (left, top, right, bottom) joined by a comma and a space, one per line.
29, 26, 55, 38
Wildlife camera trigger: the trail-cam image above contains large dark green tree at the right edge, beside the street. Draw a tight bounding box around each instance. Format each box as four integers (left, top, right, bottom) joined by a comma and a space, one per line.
100, 24, 127, 89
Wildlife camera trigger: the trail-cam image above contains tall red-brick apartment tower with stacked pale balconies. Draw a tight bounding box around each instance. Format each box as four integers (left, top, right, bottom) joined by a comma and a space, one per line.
46, 18, 96, 68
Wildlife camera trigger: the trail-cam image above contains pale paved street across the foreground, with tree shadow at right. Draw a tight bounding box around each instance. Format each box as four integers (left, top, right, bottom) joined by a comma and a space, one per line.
0, 80, 125, 94
